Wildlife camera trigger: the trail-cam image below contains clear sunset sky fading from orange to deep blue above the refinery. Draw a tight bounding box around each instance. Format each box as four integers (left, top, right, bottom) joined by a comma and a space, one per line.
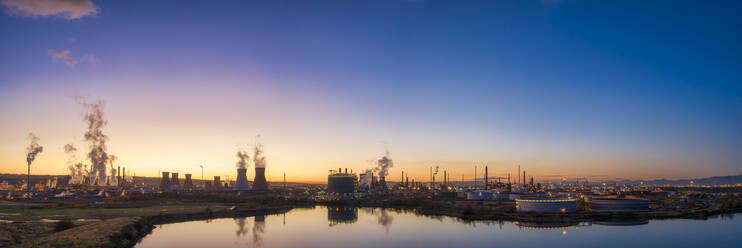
0, 0, 742, 182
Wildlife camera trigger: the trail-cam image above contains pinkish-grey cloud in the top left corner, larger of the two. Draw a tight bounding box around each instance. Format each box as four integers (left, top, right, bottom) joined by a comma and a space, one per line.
0, 0, 98, 20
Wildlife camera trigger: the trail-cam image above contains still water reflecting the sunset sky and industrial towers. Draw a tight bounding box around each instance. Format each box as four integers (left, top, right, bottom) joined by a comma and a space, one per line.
136, 207, 742, 248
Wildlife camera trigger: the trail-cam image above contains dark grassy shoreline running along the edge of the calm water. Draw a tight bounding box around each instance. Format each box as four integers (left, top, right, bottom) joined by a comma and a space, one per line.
0, 201, 742, 247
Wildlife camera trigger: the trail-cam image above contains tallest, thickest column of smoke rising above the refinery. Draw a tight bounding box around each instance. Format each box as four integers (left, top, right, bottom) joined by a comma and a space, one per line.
75, 96, 115, 184
